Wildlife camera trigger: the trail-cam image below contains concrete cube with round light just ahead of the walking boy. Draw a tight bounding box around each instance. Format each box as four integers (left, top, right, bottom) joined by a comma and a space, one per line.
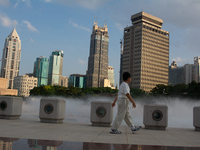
143, 105, 168, 130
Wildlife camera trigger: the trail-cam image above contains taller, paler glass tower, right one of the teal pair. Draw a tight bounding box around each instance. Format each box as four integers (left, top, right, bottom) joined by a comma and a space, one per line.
48, 50, 64, 85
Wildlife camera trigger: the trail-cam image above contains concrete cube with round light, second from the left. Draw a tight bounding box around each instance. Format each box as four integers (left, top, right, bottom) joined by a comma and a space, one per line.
39, 98, 66, 123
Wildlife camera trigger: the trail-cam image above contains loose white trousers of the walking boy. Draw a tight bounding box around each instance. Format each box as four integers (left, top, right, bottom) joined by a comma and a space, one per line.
112, 98, 134, 130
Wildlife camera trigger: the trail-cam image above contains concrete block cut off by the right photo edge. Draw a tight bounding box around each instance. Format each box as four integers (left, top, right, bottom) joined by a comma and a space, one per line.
193, 106, 200, 131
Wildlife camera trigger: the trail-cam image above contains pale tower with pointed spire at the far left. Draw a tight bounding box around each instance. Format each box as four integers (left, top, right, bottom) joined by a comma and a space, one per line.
1, 28, 21, 89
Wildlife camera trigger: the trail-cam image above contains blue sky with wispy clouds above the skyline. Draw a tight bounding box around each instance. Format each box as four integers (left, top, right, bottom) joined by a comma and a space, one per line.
0, 0, 200, 84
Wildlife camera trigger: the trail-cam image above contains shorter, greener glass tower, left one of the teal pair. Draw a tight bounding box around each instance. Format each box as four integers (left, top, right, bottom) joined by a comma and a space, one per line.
33, 56, 49, 87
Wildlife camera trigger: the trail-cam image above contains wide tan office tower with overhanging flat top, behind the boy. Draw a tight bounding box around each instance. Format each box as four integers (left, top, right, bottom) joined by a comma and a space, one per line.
122, 12, 169, 92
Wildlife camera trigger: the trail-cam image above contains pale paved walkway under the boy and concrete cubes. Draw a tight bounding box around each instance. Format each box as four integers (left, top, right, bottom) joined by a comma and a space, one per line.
0, 117, 200, 147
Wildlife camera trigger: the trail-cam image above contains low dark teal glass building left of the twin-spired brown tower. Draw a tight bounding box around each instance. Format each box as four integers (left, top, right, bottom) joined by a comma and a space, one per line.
69, 74, 86, 88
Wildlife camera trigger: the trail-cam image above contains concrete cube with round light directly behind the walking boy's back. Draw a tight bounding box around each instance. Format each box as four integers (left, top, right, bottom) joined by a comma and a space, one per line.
90, 101, 113, 127
